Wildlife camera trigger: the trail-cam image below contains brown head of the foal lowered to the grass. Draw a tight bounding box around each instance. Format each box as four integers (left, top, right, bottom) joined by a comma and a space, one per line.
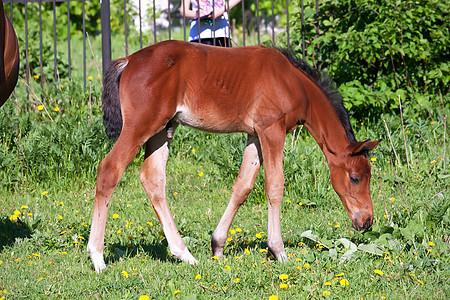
329, 140, 380, 230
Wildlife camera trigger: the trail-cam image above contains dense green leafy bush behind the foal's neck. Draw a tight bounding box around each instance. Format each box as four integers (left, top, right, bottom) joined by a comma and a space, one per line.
280, 0, 450, 118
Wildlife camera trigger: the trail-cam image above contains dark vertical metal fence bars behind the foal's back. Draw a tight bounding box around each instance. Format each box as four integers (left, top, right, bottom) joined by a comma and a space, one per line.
4, 0, 319, 90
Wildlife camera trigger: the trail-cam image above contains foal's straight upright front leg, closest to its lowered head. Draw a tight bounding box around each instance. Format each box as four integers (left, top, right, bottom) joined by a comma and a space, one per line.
258, 123, 287, 261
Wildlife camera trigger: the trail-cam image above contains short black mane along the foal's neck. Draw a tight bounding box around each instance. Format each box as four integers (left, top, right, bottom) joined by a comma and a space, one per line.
277, 49, 356, 143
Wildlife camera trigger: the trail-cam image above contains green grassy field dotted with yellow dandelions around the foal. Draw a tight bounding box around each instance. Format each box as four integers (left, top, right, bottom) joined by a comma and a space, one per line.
0, 71, 450, 299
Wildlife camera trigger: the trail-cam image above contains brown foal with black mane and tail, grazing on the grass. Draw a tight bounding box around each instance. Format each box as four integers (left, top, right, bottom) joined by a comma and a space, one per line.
88, 41, 379, 272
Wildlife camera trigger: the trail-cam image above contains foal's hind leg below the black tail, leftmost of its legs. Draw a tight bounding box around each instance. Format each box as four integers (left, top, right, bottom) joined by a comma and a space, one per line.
87, 128, 149, 272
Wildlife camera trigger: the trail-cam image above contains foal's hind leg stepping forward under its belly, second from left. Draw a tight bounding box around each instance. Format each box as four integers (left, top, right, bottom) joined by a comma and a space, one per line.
140, 126, 197, 264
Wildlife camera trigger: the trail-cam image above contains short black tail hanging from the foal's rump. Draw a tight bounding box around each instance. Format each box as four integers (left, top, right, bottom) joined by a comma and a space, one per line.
102, 58, 128, 139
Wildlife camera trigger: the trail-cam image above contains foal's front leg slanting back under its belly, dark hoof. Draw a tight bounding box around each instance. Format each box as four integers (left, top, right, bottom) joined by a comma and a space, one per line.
211, 136, 262, 257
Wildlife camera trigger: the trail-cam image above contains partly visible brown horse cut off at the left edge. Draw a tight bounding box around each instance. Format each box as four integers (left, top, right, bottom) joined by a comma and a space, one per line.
0, 0, 19, 106
